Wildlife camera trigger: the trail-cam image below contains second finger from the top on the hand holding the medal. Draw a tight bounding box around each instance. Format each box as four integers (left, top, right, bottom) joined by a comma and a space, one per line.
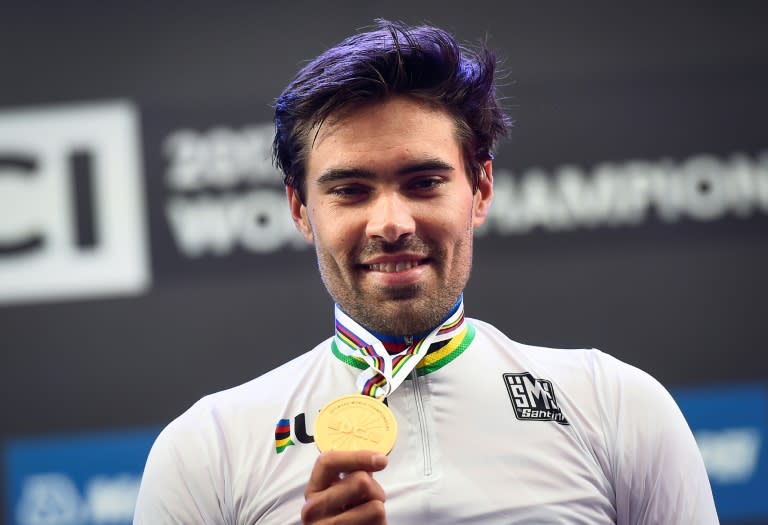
301, 470, 386, 523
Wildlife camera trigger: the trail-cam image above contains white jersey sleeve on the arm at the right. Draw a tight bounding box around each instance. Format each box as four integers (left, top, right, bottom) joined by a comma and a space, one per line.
604, 357, 719, 525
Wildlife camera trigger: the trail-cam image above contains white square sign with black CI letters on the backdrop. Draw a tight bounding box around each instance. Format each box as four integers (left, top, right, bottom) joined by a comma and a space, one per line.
0, 102, 149, 303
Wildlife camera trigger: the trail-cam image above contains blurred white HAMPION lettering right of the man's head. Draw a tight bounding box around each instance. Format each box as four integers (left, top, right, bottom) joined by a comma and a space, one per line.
486, 151, 768, 235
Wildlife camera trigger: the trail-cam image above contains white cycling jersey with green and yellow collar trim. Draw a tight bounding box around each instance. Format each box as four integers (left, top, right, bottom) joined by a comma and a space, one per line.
135, 305, 718, 525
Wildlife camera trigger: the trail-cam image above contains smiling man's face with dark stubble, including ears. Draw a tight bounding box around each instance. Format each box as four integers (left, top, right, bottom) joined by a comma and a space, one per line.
288, 97, 493, 335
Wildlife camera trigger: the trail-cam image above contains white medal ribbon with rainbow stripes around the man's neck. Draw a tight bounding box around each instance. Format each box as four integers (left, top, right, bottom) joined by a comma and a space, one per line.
336, 297, 464, 400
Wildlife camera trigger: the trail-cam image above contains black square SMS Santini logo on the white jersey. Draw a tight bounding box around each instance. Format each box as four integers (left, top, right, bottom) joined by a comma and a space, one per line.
503, 372, 570, 425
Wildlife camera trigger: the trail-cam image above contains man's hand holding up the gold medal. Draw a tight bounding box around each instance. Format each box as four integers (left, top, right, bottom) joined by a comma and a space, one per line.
301, 450, 387, 525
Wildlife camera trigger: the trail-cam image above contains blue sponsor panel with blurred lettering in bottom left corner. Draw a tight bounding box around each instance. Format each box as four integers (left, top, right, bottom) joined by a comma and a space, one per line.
5, 429, 159, 525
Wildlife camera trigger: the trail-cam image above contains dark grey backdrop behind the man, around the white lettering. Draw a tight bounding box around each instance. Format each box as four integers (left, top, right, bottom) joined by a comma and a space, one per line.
0, 0, 768, 520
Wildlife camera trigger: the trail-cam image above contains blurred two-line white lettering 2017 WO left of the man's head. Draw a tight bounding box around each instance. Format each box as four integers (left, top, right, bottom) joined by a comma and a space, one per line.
155, 118, 307, 259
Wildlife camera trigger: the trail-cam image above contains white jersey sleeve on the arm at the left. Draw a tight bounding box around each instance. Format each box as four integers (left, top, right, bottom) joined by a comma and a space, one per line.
133, 404, 230, 525
